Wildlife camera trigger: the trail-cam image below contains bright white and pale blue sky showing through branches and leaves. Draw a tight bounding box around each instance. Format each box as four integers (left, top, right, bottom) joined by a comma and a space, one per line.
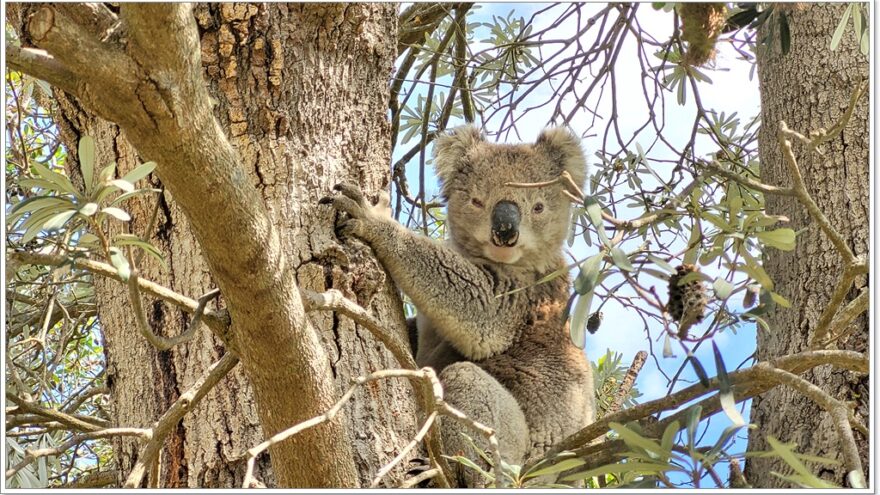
394, 4, 760, 486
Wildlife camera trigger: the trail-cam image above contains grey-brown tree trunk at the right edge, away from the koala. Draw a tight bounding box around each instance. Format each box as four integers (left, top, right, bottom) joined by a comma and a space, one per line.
745, 3, 870, 488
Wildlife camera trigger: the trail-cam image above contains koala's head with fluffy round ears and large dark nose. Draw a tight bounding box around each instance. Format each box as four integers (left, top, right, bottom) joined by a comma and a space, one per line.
434, 126, 586, 272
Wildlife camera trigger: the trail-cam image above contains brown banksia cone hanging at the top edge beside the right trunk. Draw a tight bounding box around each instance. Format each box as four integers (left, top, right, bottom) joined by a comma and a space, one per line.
678, 3, 727, 66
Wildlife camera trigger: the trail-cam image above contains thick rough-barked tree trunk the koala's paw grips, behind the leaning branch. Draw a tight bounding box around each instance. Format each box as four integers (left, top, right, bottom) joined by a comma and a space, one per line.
7, 3, 417, 487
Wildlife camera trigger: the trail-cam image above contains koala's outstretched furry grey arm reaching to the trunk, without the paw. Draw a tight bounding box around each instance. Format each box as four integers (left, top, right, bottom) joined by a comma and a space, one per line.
354, 220, 521, 360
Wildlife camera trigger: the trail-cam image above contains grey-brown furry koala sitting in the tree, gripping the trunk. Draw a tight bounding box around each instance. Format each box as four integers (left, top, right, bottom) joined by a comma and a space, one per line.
322, 126, 596, 486
